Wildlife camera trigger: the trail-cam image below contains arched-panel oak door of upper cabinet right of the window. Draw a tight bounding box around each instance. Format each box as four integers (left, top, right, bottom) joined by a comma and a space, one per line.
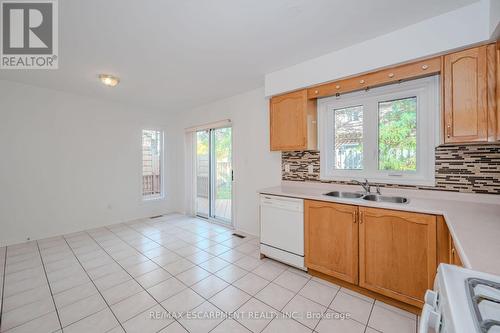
443, 46, 488, 143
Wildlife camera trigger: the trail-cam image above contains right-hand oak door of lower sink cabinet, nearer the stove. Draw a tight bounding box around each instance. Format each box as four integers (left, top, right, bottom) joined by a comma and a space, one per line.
359, 207, 437, 307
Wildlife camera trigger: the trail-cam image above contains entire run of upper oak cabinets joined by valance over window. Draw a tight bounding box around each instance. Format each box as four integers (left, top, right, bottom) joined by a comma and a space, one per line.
270, 41, 500, 151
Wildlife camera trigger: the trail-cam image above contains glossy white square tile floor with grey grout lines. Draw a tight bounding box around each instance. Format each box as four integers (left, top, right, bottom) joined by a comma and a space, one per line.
0, 215, 417, 333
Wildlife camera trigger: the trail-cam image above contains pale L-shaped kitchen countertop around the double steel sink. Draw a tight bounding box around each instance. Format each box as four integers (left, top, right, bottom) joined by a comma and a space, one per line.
259, 182, 500, 275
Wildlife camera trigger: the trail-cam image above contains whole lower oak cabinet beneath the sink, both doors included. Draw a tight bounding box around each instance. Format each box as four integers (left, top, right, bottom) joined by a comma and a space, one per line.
304, 200, 444, 308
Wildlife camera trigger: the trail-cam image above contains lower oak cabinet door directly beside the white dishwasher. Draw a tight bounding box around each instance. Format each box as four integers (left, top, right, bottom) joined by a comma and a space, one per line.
304, 200, 358, 284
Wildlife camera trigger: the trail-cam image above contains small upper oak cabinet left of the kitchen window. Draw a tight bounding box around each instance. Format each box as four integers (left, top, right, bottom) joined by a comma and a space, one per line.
269, 89, 317, 151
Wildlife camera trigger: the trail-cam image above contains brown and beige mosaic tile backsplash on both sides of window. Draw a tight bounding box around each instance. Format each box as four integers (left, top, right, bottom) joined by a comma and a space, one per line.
281, 144, 500, 194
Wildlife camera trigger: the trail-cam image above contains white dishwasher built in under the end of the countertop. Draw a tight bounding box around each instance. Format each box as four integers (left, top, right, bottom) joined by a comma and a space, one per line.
260, 194, 306, 270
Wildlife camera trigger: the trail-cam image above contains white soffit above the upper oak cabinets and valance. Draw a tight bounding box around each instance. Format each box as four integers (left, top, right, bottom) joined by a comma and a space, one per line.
265, 0, 492, 96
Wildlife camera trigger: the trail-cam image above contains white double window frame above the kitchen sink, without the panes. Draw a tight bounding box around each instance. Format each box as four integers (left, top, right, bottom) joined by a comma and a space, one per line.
318, 75, 440, 186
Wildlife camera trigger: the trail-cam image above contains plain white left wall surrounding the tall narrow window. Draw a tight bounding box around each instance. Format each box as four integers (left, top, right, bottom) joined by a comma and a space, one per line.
0, 81, 181, 245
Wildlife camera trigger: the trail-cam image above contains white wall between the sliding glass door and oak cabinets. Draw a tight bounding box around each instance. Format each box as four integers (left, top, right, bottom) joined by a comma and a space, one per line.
175, 88, 281, 234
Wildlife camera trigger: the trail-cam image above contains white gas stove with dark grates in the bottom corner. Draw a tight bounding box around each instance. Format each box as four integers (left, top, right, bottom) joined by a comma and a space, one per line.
419, 264, 500, 333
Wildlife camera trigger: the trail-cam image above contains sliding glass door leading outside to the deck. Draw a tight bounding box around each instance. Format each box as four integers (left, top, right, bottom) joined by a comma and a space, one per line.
196, 127, 233, 225
